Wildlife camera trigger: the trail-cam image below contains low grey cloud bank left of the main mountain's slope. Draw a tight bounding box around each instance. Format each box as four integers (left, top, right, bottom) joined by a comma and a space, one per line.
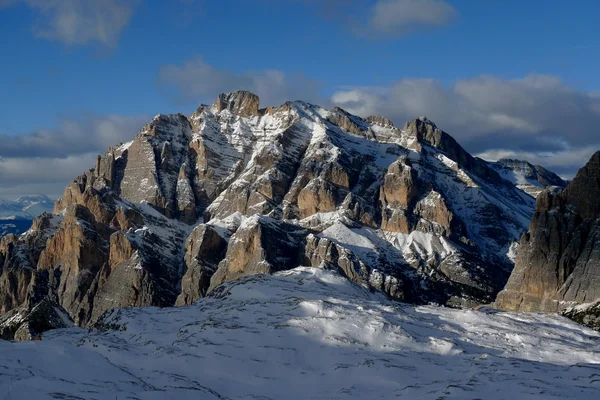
0, 115, 149, 198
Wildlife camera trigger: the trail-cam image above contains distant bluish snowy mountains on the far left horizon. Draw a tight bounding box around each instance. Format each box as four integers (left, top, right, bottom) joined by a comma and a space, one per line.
0, 196, 54, 237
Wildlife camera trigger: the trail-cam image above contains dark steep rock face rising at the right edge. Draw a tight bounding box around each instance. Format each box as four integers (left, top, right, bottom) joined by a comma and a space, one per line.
496, 152, 600, 319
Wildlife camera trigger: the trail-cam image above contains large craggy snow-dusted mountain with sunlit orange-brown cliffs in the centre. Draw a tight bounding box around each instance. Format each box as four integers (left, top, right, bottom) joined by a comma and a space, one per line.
0, 91, 535, 334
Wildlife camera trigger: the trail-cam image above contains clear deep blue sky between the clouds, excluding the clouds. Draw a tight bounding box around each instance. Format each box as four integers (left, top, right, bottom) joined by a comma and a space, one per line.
0, 0, 600, 135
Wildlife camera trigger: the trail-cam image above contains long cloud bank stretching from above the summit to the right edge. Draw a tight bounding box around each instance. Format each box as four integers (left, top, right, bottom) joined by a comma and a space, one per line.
157, 57, 600, 177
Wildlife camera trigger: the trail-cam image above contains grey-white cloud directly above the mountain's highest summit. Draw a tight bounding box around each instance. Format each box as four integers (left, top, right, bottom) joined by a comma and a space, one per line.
157, 57, 320, 106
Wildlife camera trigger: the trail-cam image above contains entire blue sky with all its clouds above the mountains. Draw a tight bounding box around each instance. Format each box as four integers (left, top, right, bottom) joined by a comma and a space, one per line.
0, 0, 600, 197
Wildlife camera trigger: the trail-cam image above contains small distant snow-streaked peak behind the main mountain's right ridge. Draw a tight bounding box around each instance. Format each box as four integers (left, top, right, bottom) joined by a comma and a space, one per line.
488, 158, 567, 197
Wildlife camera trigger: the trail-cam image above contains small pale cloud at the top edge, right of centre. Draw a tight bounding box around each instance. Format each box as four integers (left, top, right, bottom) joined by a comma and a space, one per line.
368, 0, 458, 36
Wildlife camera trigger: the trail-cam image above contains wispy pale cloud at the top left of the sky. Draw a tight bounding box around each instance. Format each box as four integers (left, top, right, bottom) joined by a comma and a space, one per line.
0, 0, 139, 47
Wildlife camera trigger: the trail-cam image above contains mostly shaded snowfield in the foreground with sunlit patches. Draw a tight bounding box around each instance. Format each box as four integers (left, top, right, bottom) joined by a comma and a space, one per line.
0, 268, 600, 400
